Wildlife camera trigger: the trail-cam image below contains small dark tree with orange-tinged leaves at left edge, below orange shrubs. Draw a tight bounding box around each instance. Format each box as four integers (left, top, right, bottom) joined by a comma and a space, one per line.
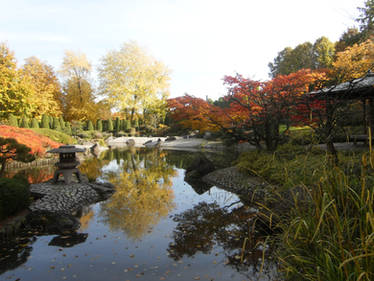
0, 137, 35, 177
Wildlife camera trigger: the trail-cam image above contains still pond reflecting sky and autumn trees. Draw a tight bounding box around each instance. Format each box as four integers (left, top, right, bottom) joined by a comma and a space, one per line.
0, 149, 276, 281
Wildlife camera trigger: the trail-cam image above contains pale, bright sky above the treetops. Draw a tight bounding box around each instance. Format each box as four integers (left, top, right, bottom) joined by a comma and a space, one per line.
0, 0, 365, 99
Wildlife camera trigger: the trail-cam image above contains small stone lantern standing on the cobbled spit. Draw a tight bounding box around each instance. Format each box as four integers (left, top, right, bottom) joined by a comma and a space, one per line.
47, 145, 85, 184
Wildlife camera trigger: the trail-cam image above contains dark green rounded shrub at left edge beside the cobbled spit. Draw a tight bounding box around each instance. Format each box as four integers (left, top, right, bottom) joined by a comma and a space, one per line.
0, 178, 30, 219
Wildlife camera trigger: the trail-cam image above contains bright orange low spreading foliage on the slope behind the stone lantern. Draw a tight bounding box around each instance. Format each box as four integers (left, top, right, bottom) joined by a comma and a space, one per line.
0, 125, 62, 157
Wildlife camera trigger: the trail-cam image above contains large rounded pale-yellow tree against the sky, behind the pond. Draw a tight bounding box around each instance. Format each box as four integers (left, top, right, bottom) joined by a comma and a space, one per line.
98, 42, 170, 123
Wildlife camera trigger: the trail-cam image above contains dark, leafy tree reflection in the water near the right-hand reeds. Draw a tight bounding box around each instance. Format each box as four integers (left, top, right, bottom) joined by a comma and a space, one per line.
168, 202, 272, 271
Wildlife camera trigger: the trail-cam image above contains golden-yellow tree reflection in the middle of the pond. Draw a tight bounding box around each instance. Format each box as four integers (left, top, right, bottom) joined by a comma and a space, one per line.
100, 150, 176, 240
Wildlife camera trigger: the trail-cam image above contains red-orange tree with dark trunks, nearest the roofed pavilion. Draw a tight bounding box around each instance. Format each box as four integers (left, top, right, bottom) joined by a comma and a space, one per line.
224, 69, 326, 150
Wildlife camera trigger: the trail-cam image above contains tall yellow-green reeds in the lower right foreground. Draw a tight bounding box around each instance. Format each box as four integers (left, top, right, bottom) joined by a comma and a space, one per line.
279, 154, 374, 281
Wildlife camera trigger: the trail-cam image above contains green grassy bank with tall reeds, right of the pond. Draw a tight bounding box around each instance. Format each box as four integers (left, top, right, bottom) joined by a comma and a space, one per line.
238, 145, 374, 280
